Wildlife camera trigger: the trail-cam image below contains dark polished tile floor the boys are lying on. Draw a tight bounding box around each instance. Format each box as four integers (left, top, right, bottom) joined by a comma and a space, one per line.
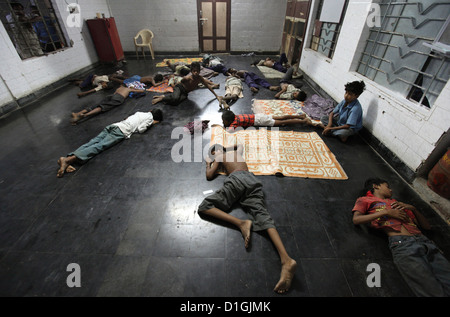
0, 56, 450, 297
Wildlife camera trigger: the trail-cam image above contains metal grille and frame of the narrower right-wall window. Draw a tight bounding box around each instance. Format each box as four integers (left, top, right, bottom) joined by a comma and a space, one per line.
311, 0, 348, 58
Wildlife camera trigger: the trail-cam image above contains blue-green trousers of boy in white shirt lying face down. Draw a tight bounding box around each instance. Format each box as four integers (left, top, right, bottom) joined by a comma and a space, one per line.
68, 125, 125, 162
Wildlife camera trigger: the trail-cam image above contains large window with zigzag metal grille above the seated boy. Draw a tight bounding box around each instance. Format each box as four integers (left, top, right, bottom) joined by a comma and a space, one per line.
356, 0, 450, 108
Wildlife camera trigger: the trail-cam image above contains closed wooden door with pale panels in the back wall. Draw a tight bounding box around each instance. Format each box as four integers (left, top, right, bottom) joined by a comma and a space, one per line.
197, 0, 231, 53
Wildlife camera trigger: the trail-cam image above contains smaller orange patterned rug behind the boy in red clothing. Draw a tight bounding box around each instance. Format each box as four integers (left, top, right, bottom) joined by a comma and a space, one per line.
252, 99, 320, 125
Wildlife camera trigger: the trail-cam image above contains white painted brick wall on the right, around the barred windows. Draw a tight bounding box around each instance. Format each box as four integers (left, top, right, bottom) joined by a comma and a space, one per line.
300, 0, 450, 171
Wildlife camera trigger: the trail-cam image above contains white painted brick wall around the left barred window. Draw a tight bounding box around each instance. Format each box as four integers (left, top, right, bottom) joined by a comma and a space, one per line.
0, 0, 108, 105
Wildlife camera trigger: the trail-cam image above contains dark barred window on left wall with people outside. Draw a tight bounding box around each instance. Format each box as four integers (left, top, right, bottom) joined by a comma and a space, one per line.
0, 0, 66, 59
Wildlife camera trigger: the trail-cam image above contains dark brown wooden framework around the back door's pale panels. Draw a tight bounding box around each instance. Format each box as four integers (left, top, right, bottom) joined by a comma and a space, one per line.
197, 0, 231, 53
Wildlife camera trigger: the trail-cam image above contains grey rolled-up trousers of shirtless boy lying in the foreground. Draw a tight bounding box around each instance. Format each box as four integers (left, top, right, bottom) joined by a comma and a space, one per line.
198, 171, 275, 231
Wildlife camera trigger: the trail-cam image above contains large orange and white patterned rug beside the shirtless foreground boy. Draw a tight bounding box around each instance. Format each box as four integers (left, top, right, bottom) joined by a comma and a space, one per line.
210, 125, 348, 180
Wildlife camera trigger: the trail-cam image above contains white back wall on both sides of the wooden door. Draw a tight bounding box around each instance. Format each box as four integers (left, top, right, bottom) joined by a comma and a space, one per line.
108, 0, 287, 53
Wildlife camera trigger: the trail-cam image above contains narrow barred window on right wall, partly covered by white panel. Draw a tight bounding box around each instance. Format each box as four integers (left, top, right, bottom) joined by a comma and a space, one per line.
311, 0, 348, 58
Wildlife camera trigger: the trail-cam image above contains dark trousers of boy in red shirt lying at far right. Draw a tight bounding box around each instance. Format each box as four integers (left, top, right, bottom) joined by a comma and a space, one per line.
389, 235, 450, 297
